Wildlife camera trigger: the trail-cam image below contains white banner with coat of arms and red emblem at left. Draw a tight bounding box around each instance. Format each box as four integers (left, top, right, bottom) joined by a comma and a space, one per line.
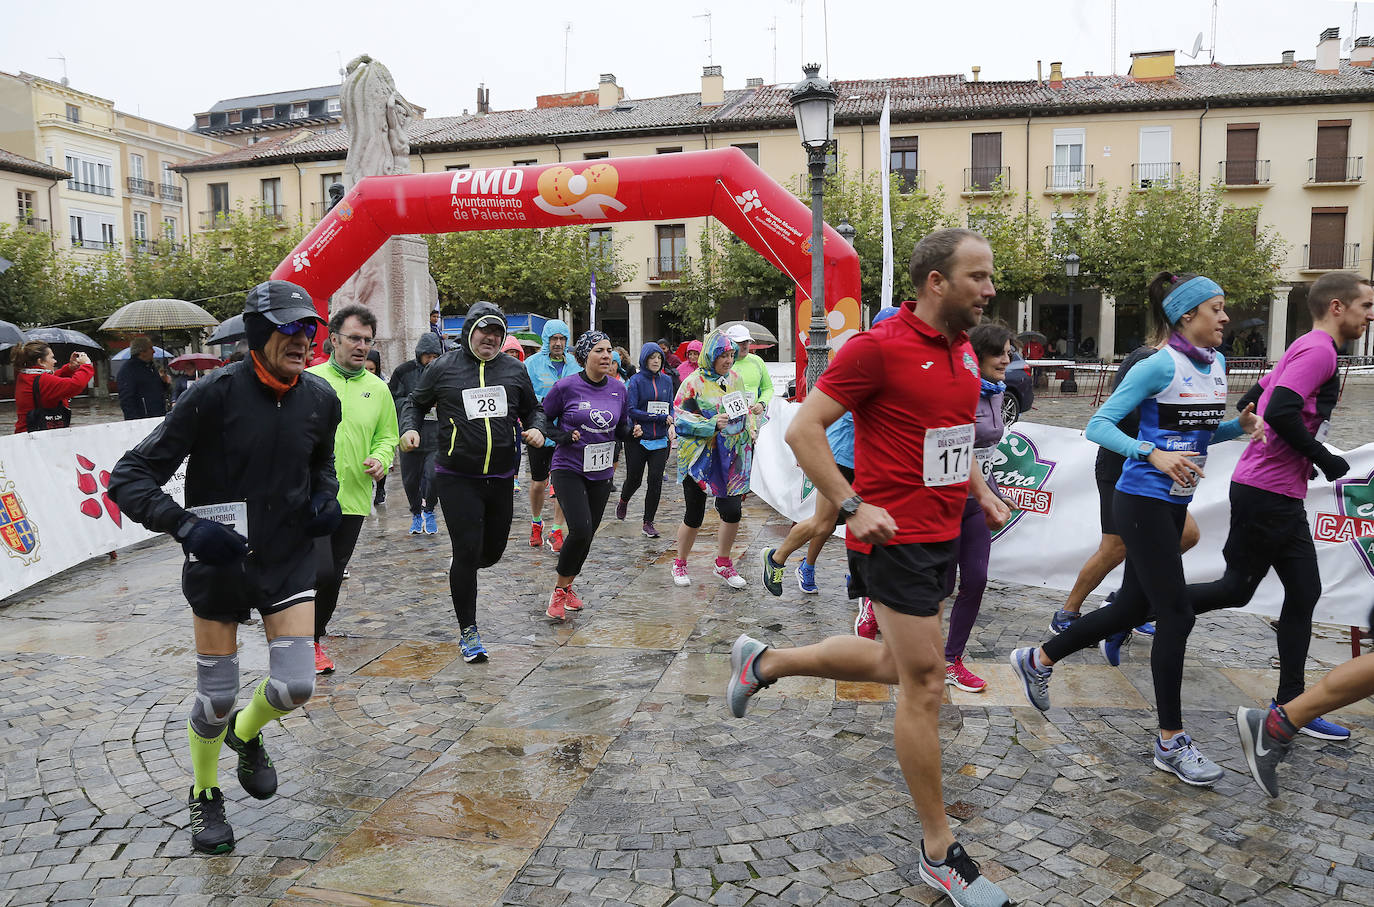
0, 419, 185, 598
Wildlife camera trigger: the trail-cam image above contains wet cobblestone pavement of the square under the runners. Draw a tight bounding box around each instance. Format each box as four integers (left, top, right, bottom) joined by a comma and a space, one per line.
0, 390, 1374, 907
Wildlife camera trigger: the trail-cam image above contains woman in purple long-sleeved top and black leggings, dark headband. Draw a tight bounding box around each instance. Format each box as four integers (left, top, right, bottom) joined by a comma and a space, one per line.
544, 331, 643, 620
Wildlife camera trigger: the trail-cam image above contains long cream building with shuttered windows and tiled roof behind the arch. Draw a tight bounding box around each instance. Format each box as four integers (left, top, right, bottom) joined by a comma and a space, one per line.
180, 29, 1374, 359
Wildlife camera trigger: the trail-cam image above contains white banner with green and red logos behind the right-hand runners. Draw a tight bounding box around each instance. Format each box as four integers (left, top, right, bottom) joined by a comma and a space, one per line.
750, 403, 1374, 627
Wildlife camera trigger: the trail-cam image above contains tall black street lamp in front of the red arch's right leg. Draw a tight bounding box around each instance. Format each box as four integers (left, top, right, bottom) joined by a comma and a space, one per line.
789, 63, 852, 389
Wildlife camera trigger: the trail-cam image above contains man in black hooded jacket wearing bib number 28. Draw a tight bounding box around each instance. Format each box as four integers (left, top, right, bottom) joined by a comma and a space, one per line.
401, 302, 544, 662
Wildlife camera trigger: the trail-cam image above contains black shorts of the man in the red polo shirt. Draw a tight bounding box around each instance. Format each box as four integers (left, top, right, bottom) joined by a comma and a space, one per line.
849, 539, 959, 617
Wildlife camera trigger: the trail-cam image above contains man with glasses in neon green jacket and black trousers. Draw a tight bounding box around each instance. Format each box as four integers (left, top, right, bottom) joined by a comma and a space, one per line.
308, 305, 400, 673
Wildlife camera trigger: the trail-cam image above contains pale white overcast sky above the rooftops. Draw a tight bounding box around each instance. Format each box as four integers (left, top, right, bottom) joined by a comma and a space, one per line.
0, 0, 1374, 128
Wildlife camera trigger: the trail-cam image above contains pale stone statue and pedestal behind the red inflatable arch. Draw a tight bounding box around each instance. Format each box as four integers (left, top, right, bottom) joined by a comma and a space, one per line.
330, 54, 438, 371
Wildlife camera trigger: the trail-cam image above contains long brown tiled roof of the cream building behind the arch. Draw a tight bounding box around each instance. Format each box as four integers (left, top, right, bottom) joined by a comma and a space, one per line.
179, 60, 1374, 170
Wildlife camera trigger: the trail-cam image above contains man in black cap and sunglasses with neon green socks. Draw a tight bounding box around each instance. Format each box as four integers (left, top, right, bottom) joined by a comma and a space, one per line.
110, 280, 339, 853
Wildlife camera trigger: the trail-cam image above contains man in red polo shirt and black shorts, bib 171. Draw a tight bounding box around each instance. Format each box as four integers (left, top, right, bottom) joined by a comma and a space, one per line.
727, 229, 1010, 907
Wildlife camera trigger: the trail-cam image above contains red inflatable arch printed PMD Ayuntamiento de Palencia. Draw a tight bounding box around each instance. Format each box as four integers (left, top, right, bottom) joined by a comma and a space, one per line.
272, 148, 861, 392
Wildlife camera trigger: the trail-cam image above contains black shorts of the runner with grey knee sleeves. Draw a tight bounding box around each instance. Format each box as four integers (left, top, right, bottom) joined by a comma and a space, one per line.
181, 546, 316, 624
